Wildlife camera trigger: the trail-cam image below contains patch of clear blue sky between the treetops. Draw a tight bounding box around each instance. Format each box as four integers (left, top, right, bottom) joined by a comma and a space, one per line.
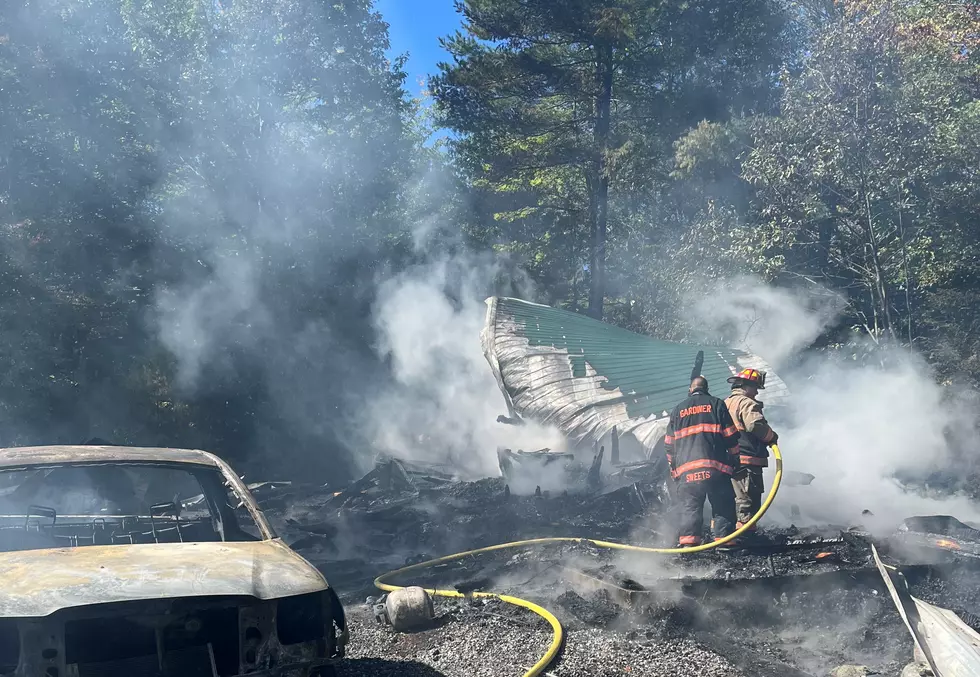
375, 0, 460, 96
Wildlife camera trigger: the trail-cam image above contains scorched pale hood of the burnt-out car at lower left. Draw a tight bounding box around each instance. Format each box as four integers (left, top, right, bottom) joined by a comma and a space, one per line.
0, 539, 327, 618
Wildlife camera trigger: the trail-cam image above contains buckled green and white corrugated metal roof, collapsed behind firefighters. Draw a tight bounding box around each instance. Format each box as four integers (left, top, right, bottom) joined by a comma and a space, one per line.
481, 296, 788, 450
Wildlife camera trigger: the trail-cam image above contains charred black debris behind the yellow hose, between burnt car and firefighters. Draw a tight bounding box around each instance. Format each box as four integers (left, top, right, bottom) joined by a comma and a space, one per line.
264, 449, 673, 593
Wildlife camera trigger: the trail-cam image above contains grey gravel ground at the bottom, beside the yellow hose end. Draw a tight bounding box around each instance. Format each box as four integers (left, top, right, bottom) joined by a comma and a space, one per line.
338, 602, 746, 677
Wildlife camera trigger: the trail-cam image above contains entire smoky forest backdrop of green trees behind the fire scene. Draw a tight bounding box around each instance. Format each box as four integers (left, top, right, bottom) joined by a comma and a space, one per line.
0, 0, 980, 479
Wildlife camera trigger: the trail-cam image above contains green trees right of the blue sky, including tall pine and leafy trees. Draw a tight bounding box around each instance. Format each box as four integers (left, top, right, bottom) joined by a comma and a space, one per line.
442, 0, 980, 378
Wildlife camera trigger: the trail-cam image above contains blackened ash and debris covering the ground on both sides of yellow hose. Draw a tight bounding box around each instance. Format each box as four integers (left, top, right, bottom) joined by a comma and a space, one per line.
254, 450, 980, 677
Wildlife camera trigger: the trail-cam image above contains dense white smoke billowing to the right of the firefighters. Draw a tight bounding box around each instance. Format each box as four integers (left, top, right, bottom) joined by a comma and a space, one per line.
700, 279, 980, 529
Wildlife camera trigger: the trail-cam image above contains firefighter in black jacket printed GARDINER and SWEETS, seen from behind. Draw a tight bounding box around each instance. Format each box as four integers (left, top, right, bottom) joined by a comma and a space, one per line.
664, 376, 739, 546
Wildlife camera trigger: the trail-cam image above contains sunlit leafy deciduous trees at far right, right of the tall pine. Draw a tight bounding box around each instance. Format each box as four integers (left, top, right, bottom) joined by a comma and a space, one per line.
676, 1, 980, 378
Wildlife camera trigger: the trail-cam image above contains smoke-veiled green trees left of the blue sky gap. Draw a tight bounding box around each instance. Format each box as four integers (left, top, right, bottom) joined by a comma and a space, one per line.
0, 0, 420, 470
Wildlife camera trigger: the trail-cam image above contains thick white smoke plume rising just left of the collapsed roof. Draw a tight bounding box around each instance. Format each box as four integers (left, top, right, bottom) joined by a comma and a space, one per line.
363, 257, 562, 477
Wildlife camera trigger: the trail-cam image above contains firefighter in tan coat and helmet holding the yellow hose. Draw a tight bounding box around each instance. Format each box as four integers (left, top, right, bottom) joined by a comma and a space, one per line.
725, 369, 779, 530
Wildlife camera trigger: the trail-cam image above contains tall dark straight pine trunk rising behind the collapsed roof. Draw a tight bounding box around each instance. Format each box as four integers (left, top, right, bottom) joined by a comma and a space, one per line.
589, 45, 613, 320
